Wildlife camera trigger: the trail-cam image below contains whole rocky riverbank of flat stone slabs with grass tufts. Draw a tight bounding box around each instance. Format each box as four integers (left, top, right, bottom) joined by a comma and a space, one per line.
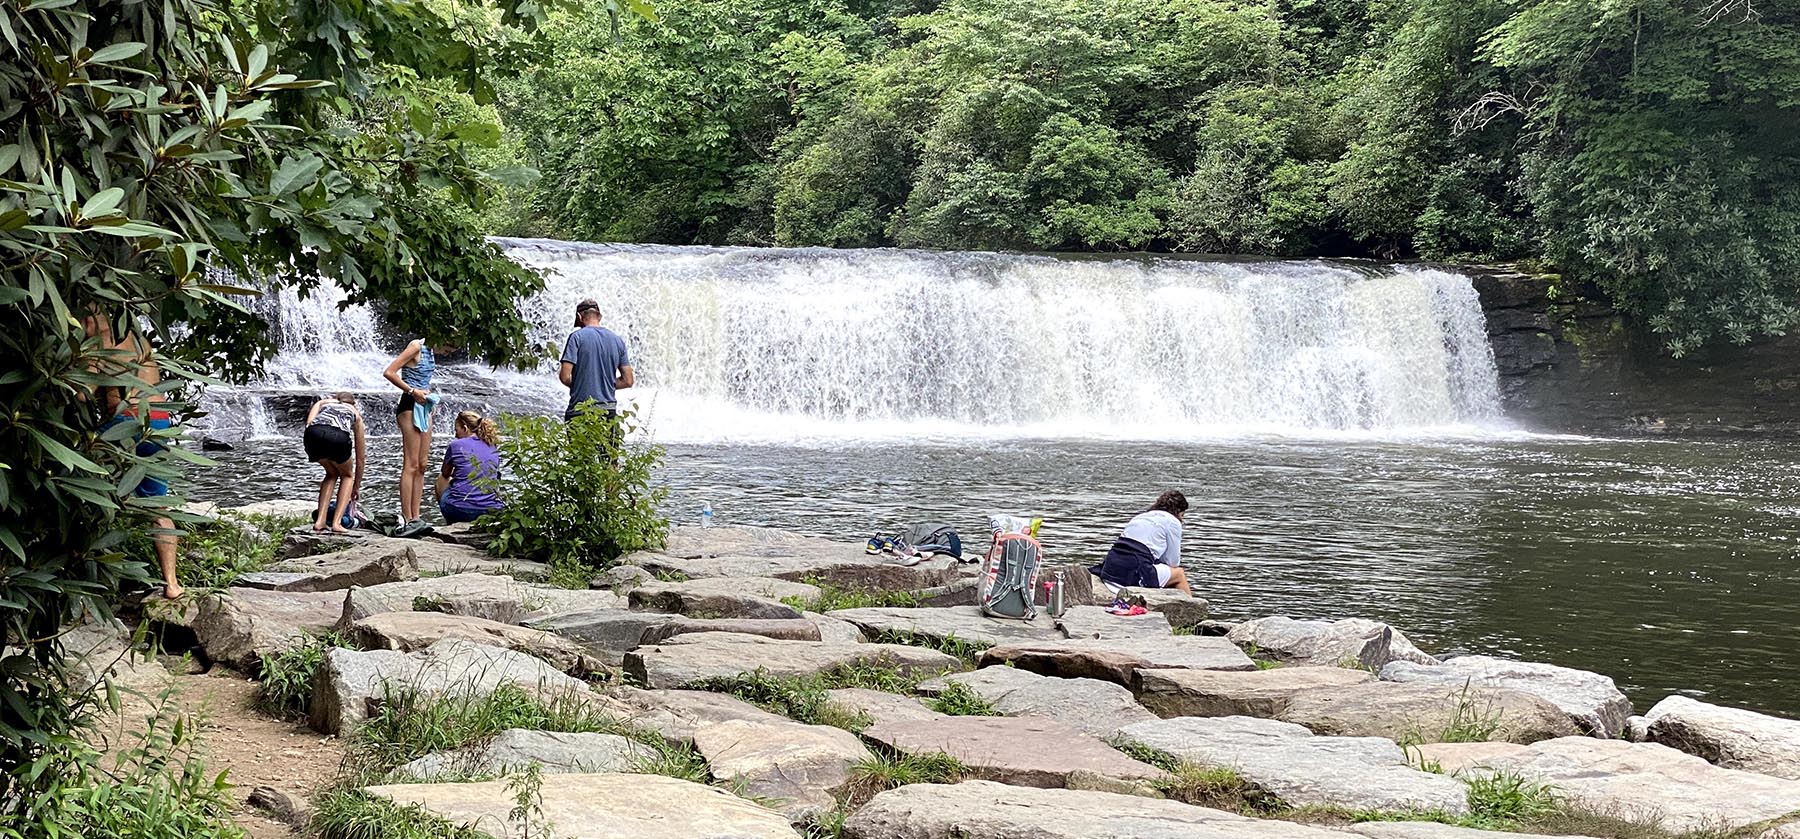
88, 513, 1800, 839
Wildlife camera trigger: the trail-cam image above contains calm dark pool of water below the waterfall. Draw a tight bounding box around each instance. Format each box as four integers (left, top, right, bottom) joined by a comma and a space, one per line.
194, 438, 1800, 717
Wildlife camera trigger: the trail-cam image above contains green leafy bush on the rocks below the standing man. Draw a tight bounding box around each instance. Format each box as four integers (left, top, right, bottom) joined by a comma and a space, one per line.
482, 410, 668, 565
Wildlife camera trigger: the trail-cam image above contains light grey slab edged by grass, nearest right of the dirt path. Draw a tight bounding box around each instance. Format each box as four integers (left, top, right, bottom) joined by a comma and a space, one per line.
391, 729, 653, 781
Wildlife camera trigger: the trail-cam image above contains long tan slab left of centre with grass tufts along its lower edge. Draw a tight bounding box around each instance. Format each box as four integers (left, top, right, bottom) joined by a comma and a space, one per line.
625, 632, 963, 688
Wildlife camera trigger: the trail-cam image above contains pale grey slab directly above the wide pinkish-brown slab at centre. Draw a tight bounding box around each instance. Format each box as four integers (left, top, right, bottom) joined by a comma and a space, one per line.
920, 668, 1156, 740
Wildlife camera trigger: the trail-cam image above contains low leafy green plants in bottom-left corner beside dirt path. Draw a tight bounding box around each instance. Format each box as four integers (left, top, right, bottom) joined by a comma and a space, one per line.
0, 695, 245, 839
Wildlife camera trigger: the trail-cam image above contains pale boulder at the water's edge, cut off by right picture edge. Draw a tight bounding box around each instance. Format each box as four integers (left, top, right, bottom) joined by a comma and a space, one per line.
1643, 697, 1800, 780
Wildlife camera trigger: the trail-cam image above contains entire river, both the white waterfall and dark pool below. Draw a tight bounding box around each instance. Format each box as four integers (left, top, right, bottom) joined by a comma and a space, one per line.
182, 247, 1800, 717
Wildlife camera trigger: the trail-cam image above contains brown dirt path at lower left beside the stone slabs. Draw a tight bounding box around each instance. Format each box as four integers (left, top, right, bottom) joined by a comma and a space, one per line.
175, 668, 344, 839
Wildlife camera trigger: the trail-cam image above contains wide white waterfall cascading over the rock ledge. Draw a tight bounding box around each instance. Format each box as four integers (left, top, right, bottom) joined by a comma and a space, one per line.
200, 239, 1503, 441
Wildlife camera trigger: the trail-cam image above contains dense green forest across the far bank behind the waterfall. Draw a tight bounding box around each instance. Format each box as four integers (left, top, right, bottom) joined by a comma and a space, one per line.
491, 0, 1800, 355
